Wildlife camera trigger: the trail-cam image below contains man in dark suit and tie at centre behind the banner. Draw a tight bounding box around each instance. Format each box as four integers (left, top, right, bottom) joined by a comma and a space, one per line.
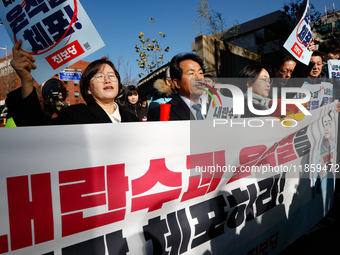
148, 53, 204, 121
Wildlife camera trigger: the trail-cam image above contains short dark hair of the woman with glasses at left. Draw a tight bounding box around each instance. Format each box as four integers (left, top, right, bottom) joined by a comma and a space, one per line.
79, 58, 122, 104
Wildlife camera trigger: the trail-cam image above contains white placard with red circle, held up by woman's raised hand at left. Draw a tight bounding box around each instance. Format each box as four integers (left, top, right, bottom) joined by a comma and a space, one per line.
0, 0, 104, 84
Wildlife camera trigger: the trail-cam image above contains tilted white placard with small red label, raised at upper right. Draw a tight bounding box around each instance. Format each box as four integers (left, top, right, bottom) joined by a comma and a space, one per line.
283, 0, 313, 65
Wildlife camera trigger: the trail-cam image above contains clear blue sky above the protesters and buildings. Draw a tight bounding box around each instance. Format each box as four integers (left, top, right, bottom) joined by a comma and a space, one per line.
0, 0, 334, 81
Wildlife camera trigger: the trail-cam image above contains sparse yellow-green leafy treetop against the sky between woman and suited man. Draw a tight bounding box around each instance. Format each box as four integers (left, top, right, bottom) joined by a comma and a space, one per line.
135, 18, 170, 77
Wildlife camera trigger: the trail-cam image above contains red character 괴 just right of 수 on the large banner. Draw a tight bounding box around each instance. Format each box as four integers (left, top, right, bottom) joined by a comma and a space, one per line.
181, 151, 225, 202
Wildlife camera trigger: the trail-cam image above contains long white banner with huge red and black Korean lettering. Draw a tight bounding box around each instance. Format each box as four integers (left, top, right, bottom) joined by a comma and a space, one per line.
0, 100, 339, 255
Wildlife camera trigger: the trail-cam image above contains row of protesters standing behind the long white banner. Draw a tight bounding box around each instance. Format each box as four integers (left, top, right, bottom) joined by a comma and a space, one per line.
6, 37, 340, 126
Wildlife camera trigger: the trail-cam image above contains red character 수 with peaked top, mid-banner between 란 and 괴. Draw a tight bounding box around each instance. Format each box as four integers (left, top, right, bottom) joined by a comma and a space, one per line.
131, 158, 182, 212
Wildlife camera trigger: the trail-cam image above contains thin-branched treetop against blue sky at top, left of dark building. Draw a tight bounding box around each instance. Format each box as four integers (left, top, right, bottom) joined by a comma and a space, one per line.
193, 0, 225, 39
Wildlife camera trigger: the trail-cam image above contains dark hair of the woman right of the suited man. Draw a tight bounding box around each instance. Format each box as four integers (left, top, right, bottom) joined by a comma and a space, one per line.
238, 64, 273, 92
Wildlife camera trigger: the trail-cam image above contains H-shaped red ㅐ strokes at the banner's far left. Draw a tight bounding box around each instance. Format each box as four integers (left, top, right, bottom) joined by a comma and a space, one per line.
7, 173, 54, 250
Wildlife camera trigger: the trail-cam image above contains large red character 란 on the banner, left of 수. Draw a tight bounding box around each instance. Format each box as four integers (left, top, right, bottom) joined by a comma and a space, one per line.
59, 164, 128, 236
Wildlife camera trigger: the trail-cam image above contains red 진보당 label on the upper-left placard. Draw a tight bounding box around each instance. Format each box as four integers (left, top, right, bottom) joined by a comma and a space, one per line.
46, 41, 85, 70
